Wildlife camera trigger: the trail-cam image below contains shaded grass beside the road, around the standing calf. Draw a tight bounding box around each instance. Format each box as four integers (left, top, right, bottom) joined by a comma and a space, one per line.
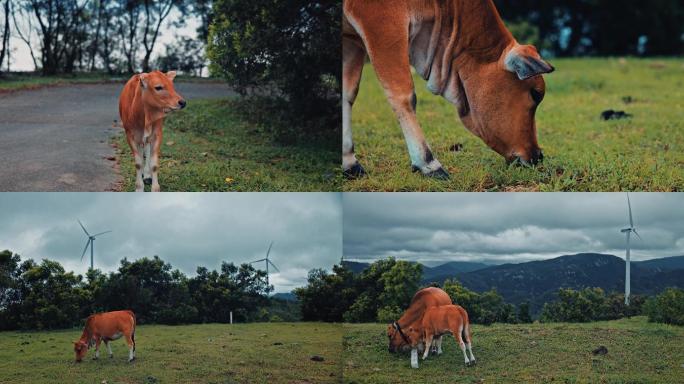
116, 99, 341, 192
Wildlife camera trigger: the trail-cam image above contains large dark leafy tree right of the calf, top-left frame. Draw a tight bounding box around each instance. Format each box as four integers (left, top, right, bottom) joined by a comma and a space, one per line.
207, 0, 342, 138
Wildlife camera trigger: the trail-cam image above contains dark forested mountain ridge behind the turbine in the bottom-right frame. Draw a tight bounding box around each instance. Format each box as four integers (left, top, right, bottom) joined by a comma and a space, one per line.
454, 253, 684, 311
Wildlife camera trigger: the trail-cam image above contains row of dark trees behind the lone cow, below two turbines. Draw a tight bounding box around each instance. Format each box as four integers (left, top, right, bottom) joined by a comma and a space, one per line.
0, 251, 297, 330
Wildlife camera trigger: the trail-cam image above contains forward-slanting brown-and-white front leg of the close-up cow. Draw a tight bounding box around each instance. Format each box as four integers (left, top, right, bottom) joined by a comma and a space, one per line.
356, 13, 449, 179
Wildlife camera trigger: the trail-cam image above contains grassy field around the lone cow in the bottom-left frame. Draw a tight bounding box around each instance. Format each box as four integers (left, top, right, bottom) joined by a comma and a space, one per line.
0, 323, 342, 384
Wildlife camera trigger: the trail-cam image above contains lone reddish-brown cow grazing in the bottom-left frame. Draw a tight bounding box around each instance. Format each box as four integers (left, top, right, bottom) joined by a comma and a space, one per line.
74, 311, 135, 363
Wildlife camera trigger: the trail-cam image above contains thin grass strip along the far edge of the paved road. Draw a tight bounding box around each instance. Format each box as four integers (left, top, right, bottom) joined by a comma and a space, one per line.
0, 72, 221, 93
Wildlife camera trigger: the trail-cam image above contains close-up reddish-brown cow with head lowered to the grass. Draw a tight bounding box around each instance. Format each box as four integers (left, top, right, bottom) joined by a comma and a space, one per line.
342, 0, 554, 179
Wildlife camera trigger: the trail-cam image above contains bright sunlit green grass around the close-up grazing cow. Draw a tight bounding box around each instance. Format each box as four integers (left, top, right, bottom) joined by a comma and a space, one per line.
344, 58, 684, 191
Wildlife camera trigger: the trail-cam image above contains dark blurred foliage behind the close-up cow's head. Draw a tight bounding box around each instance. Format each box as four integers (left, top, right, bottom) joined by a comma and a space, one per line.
494, 0, 684, 56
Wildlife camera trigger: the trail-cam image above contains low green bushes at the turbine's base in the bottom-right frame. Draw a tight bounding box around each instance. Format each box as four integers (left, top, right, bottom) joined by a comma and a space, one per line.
540, 288, 644, 323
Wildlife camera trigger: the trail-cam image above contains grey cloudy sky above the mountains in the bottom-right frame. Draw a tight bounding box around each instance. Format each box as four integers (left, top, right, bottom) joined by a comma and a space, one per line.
343, 193, 684, 266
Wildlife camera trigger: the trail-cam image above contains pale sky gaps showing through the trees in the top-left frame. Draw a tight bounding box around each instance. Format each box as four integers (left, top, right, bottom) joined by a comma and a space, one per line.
8, 9, 199, 72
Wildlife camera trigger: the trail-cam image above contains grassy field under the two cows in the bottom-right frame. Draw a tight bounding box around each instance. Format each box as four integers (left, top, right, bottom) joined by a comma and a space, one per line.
343, 317, 684, 384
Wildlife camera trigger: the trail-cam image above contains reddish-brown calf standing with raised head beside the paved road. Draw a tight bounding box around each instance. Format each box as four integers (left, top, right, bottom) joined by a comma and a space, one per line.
119, 71, 186, 192
